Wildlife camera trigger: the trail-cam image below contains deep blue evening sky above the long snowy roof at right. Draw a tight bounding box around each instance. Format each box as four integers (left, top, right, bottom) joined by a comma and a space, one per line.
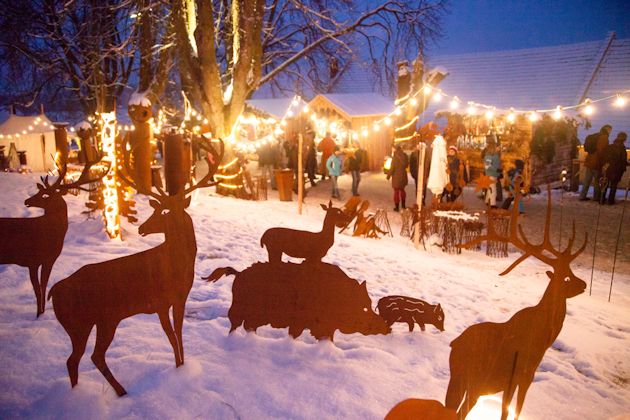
430, 0, 630, 55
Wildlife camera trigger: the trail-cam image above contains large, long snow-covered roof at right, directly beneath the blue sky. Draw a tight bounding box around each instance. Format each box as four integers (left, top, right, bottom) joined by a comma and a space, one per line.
424, 34, 630, 138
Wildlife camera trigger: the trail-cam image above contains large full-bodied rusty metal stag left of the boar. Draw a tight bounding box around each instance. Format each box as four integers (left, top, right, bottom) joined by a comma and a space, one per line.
48, 142, 223, 396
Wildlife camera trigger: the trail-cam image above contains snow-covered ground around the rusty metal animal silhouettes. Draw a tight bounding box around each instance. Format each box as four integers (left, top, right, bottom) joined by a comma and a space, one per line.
0, 174, 630, 419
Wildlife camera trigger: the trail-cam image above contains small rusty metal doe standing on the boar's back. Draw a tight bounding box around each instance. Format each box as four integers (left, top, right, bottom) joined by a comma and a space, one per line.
260, 201, 347, 264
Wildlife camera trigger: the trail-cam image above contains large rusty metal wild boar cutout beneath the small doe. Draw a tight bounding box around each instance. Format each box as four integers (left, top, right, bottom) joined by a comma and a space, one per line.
205, 263, 391, 341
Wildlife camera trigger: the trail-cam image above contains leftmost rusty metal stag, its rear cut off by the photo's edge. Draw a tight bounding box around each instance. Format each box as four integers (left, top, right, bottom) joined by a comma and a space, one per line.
0, 162, 109, 317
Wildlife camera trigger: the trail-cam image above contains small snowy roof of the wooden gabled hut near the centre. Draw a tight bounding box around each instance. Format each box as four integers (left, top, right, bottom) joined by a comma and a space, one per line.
313, 93, 394, 118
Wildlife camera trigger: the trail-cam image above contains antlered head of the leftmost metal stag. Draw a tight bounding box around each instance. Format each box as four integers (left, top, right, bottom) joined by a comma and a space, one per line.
24, 159, 109, 209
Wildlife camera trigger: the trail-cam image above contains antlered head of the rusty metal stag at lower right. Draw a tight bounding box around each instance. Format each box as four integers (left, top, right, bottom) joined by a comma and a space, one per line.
462, 187, 588, 299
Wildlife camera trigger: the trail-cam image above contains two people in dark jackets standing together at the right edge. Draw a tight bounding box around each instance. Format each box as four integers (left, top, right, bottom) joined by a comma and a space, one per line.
580, 124, 628, 204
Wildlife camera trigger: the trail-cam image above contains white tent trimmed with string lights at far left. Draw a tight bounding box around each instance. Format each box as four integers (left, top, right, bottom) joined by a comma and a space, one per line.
0, 114, 56, 172
